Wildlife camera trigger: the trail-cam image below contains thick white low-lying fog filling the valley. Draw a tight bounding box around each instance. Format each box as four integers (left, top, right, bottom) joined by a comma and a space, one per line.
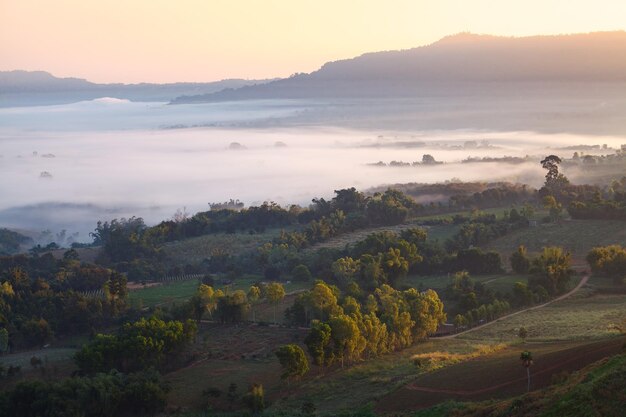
0, 99, 625, 241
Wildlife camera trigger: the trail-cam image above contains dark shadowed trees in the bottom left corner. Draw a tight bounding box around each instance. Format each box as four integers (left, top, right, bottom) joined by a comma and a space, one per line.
0, 371, 167, 417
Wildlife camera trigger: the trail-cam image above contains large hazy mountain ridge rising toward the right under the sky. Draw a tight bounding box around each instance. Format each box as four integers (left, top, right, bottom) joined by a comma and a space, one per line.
173, 31, 626, 103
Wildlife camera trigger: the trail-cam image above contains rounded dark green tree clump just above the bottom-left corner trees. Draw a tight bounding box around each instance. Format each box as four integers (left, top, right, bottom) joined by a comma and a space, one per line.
74, 316, 197, 374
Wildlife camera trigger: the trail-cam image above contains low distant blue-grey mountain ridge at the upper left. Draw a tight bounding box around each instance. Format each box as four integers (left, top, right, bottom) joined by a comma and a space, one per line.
0, 71, 272, 107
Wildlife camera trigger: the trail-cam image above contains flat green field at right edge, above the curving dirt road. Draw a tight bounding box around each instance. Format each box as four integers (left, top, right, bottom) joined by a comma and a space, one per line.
485, 220, 626, 263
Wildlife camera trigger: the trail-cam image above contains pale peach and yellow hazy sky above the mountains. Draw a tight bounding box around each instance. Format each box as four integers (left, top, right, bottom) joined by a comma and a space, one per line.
0, 0, 626, 82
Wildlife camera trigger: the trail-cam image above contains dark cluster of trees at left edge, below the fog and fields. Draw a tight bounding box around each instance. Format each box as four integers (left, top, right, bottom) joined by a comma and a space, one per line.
0, 255, 127, 350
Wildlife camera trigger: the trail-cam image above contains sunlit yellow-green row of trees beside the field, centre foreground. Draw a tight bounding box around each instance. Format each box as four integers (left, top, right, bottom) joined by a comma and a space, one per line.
285, 281, 446, 366
